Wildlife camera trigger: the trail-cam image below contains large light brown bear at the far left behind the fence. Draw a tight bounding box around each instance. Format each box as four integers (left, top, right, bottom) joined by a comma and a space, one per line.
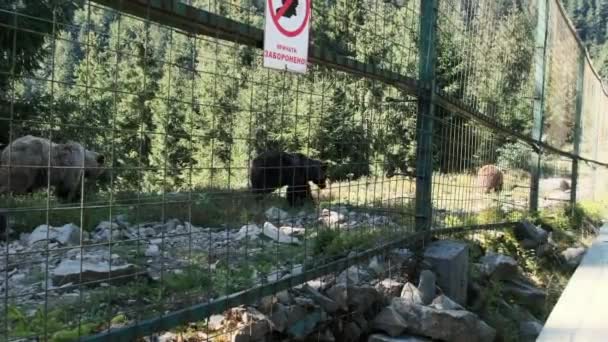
0, 135, 104, 202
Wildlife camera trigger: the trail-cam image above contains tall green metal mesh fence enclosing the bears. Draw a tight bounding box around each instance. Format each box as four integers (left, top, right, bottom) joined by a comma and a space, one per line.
0, 0, 608, 341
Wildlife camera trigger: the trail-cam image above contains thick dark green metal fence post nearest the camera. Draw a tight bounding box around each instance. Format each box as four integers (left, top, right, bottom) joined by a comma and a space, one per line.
416, 0, 438, 232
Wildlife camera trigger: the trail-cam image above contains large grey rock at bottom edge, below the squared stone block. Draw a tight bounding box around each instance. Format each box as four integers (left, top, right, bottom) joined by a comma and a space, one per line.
391, 298, 496, 342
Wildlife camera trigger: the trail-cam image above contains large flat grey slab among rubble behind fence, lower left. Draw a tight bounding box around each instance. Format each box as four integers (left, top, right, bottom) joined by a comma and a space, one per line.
51, 259, 136, 286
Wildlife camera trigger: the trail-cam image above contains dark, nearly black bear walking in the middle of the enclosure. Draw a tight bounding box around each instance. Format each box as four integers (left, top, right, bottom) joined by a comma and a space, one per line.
250, 151, 326, 206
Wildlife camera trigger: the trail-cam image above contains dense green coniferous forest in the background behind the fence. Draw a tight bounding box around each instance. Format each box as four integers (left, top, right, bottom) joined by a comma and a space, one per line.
0, 0, 533, 198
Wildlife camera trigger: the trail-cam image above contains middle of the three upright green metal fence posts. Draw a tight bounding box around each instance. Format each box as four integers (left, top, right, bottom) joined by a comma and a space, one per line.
530, 0, 549, 212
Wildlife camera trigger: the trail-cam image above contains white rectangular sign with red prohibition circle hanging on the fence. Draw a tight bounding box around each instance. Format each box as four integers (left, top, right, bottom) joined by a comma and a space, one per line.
264, 0, 311, 73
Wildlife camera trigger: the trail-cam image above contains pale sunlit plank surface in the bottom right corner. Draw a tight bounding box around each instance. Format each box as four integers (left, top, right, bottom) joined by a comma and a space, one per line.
537, 225, 608, 342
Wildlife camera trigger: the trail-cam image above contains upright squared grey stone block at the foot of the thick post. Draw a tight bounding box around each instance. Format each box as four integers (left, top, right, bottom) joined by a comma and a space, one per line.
424, 240, 469, 305
